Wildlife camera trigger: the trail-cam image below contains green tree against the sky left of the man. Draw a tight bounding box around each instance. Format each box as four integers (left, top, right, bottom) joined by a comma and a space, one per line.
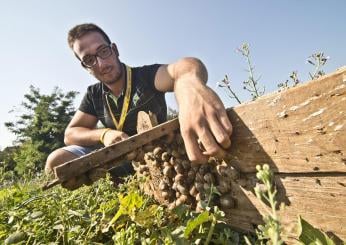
5, 86, 77, 174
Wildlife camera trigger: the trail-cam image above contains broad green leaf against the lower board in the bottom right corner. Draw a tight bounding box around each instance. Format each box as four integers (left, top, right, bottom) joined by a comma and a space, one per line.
298, 216, 335, 245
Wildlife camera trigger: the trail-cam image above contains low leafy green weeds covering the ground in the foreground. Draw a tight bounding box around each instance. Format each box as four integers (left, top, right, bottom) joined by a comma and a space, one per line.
0, 177, 245, 244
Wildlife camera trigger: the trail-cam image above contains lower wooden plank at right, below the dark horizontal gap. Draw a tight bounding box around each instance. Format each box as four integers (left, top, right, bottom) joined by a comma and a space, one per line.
226, 173, 346, 240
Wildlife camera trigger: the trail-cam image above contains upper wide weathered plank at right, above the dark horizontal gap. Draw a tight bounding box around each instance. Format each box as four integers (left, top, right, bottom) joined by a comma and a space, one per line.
228, 67, 346, 173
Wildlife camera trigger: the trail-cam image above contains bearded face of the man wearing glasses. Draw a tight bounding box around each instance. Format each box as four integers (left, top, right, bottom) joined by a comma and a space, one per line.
73, 32, 122, 85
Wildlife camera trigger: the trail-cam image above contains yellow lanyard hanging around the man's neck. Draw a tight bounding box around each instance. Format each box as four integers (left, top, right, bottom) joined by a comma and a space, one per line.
106, 66, 132, 131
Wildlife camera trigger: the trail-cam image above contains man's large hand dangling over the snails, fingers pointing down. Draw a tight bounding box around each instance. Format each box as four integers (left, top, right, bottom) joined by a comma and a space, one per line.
174, 79, 232, 163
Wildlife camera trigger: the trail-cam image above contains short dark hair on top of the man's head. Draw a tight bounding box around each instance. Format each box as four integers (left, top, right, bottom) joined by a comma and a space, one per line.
67, 23, 111, 49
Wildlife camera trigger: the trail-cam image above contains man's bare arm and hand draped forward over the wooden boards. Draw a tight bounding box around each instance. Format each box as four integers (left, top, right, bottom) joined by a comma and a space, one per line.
155, 58, 232, 163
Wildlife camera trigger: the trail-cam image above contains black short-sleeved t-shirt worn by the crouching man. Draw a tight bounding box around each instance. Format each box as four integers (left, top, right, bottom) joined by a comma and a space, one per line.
79, 64, 167, 135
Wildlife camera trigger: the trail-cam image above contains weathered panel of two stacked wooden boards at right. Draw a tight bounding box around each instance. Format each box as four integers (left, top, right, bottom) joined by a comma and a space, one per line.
222, 68, 346, 242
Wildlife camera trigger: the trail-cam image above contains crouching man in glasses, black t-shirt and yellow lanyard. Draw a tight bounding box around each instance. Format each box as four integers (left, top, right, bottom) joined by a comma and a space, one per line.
45, 24, 232, 189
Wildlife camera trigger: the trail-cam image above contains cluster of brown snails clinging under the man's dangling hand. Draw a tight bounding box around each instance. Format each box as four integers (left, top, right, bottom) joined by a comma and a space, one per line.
131, 133, 239, 211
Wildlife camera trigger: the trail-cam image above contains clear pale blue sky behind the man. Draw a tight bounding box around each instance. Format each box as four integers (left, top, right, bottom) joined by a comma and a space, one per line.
0, 0, 346, 148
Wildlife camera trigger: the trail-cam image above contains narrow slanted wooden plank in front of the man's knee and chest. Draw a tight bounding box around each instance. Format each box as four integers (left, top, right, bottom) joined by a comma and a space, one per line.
54, 118, 179, 182
